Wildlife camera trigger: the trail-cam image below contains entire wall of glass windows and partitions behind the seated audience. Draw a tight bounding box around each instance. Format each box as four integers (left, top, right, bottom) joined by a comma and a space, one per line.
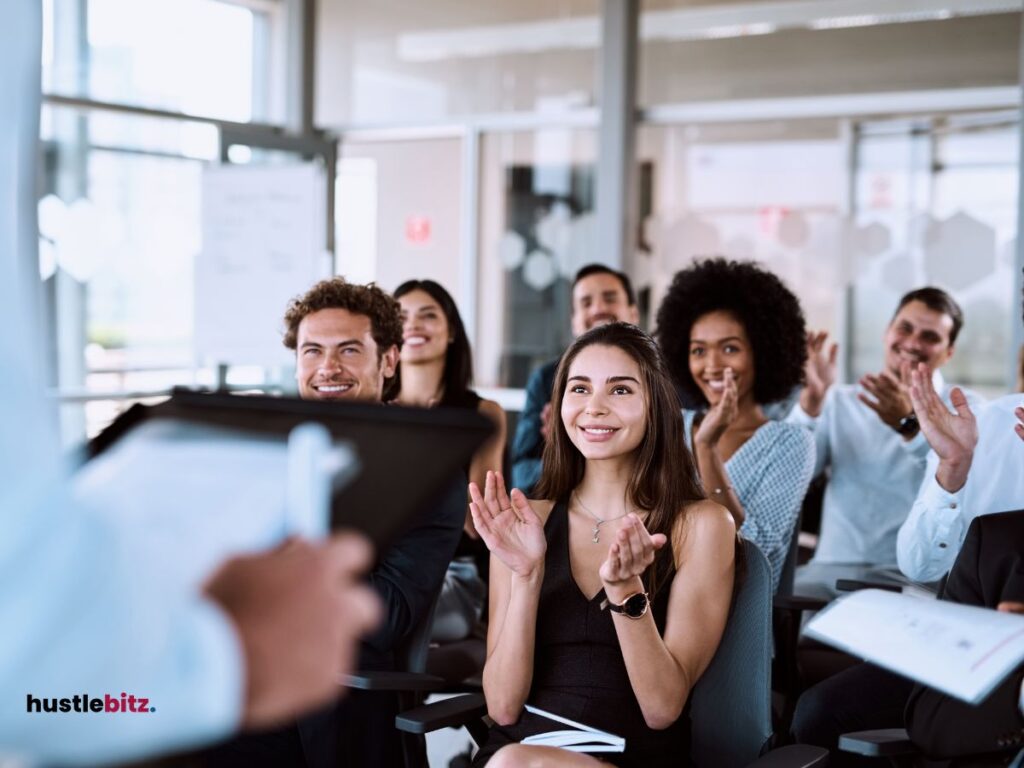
40, 0, 1021, 439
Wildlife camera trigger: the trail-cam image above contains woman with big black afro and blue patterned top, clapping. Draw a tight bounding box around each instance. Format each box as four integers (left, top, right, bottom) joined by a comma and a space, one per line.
655, 258, 814, 589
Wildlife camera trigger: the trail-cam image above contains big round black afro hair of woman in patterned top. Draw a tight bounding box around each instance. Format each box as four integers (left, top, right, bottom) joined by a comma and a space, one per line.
654, 257, 807, 404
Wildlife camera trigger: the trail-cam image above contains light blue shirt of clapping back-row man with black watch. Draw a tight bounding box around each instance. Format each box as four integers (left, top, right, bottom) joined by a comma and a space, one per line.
788, 371, 981, 566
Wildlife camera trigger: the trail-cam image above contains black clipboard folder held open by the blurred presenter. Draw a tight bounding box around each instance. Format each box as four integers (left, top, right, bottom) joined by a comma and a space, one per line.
87, 389, 494, 551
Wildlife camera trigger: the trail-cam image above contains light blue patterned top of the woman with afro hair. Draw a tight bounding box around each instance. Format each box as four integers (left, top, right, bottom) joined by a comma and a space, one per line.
683, 411, 814, 592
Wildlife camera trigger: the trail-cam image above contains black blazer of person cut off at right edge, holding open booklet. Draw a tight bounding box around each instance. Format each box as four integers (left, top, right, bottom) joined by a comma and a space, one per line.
906, 510, 1024, 765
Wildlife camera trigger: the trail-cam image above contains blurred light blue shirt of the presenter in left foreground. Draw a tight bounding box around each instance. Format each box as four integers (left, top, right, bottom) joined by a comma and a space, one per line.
0, 0, 244, 764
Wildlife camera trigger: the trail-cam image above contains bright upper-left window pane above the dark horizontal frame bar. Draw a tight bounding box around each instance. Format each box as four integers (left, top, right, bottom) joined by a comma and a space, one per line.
43, 0, 285, 122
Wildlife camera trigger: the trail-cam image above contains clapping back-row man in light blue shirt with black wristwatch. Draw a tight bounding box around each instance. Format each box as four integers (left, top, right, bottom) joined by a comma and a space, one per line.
788, 288, 973, 599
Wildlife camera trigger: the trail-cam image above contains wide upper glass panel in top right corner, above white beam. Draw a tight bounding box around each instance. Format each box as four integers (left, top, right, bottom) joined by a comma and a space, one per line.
639, 0, 1020, 106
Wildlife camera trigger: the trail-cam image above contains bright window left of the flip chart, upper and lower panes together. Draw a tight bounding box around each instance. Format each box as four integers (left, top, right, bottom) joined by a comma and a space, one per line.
40, 0, 285, 441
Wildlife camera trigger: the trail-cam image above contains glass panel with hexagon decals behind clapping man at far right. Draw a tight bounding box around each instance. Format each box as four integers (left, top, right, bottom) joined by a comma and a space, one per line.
852, 114, 1020, 395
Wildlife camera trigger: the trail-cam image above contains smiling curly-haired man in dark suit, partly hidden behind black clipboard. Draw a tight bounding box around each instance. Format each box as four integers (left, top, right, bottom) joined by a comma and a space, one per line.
218, 278, 466, 768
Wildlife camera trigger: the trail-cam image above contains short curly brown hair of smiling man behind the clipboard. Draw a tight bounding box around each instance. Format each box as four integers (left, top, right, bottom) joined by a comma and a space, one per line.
284, 278, 401, 357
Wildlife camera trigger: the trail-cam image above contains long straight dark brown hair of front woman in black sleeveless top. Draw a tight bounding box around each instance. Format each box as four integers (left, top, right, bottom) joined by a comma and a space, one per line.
537, 323, 707, 595
